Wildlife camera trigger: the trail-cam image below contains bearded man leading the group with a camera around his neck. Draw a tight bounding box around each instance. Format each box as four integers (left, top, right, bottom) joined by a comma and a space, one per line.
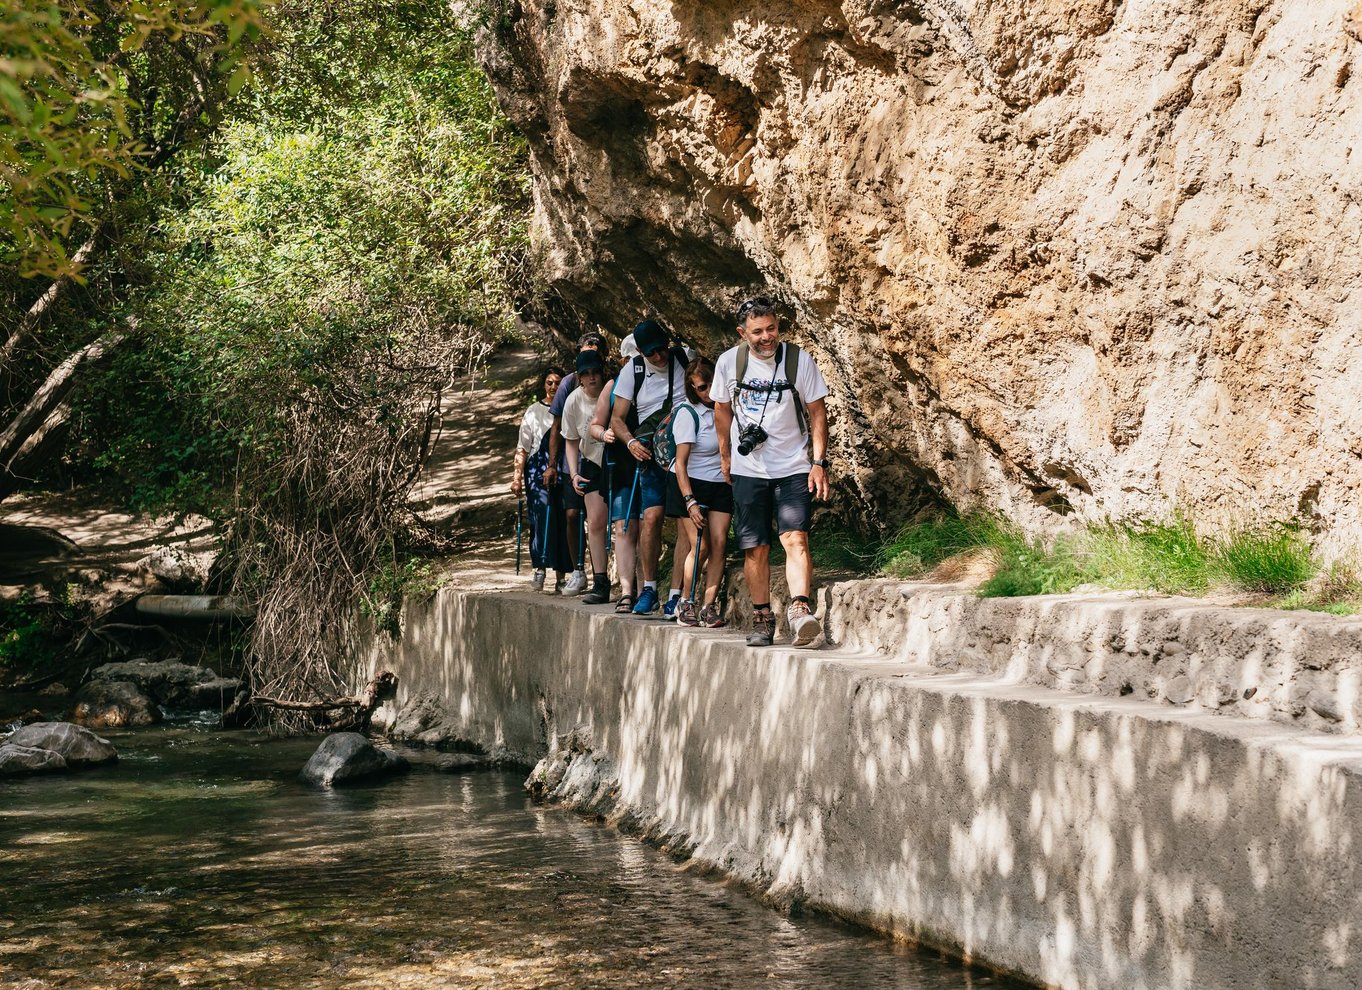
710, 298, 828, 647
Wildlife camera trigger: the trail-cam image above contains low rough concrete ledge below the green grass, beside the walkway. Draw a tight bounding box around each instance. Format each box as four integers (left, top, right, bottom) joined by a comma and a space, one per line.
823, 580, 1362, 734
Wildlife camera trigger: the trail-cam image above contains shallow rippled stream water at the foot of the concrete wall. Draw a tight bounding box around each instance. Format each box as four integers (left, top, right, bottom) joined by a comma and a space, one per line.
0, 727, 1024, 990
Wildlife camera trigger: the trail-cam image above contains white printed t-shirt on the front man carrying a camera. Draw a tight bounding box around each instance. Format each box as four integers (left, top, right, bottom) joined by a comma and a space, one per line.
710, 343, 828, 478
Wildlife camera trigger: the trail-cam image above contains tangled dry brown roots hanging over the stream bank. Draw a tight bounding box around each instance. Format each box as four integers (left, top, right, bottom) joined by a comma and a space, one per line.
229, 331, 490, 733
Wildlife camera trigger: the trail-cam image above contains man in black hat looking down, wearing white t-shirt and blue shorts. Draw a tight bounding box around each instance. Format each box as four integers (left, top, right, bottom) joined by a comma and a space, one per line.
610, 320, 686, 616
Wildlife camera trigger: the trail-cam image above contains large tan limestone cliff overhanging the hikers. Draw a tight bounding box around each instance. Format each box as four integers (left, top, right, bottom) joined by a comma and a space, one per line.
482, 0, 1362, 553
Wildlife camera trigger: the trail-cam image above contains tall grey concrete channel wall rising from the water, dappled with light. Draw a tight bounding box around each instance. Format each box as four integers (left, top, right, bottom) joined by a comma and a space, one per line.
372, 590, 1362, 990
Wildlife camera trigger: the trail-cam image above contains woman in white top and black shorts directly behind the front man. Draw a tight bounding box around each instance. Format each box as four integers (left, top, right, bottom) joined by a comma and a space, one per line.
667, 357, 733, 629
